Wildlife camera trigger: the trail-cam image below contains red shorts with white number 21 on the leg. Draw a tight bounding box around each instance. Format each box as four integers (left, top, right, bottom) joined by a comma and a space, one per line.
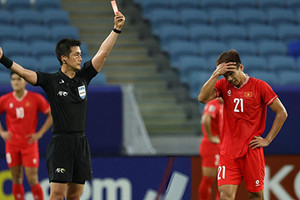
217, 148, 265, 193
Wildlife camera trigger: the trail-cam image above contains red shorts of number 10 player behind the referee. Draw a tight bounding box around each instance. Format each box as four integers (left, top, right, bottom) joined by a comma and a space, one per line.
5, 143, 39, 168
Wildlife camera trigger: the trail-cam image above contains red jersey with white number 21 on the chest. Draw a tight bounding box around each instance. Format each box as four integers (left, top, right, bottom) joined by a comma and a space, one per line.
215, 76, 277, 159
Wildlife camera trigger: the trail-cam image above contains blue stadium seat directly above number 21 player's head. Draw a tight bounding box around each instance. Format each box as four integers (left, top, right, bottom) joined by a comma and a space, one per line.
229, 40, 257, 56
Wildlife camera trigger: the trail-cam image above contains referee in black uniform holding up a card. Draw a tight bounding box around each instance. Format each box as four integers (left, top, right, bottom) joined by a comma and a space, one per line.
0, 12, 125, 200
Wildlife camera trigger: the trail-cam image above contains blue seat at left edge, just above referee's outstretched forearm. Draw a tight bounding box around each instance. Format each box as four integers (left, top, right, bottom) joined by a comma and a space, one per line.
1, 41, 30, 57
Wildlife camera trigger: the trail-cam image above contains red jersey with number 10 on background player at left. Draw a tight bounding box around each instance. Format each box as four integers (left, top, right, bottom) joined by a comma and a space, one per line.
0, 90, 50, 146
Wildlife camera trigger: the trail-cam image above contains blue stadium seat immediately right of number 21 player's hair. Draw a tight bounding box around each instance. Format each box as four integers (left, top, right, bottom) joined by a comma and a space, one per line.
241, 56, 269, 72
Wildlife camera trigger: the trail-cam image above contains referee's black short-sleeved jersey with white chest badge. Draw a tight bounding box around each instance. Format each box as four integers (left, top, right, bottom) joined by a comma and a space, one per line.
35, 60, 98, 134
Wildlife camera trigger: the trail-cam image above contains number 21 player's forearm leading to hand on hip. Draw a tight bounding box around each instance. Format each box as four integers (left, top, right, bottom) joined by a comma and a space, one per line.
265, 110, 288, 144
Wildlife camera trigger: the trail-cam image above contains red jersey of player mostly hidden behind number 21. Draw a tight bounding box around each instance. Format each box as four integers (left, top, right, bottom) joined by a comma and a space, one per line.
200, 99, 223, 156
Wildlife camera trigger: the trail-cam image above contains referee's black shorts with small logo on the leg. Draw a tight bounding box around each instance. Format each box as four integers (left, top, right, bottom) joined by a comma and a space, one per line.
47, 134, 92, 184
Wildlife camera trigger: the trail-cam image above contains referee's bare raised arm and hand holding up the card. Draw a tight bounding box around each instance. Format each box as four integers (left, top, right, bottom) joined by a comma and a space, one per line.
92, 12, 125, 72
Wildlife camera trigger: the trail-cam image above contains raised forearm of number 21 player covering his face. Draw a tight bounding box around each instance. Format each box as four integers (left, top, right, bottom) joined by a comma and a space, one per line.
198, 73, 219, 103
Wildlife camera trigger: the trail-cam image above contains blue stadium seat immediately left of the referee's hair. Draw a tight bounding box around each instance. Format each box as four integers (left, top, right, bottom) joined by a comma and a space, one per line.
30, 41, 56, 58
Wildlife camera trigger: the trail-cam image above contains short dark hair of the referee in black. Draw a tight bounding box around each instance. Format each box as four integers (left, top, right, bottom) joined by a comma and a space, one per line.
55, 38, 81, 65
